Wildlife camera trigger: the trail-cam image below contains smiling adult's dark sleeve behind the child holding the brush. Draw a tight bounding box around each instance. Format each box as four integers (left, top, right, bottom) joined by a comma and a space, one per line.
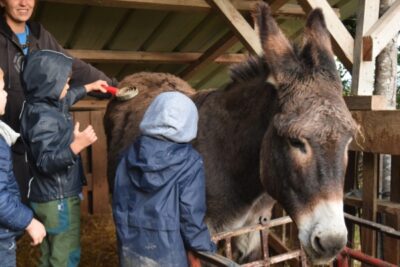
41, 26, 118, 98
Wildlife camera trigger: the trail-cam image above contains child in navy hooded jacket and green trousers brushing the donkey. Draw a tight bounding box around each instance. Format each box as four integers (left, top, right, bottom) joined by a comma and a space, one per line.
20, 50, 107, 267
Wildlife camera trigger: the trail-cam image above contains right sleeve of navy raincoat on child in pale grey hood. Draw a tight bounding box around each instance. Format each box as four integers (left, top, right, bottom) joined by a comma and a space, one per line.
179, 160, 215, 252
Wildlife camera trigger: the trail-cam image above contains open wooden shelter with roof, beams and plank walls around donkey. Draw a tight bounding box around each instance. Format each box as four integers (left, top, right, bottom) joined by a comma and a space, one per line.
34, 0, 400, 265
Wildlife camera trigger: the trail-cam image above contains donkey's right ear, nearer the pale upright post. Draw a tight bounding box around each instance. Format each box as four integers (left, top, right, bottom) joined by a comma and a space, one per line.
301, 8, 336, 72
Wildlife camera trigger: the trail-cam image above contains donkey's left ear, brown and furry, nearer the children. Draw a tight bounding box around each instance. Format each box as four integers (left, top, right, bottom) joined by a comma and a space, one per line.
253, 2, 300, 84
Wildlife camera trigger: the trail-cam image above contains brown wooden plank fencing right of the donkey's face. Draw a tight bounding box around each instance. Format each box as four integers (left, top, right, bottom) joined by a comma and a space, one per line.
345, 100, 400, 266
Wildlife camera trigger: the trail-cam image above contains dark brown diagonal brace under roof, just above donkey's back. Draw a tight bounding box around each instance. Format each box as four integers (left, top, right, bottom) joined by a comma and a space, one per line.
179, 32, 238, 80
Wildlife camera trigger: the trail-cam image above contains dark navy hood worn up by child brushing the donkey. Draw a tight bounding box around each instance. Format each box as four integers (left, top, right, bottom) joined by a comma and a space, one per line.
22, 50, 72, 104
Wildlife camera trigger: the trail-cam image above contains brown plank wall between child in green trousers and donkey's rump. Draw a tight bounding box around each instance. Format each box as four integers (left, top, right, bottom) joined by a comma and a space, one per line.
71, 100, 111, 214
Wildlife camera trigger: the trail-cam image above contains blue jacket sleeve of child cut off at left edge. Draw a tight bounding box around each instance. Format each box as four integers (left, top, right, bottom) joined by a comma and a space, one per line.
0, 145, 33, 231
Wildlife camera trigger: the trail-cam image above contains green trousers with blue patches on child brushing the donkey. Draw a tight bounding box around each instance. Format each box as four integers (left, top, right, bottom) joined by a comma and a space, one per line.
30, 196, 81, 267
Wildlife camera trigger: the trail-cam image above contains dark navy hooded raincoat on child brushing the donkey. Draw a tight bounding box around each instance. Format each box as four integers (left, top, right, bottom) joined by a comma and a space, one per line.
21, 50, 86, 202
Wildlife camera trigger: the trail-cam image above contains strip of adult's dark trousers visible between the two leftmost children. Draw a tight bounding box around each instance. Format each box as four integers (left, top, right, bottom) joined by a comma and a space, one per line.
12, 151, 31, 204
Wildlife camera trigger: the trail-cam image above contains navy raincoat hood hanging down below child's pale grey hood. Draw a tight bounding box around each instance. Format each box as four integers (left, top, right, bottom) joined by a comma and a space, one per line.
125, 136, 192, 192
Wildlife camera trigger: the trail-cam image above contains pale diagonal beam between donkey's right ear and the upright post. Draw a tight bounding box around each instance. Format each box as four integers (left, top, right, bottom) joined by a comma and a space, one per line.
298, 0, 354, 70
